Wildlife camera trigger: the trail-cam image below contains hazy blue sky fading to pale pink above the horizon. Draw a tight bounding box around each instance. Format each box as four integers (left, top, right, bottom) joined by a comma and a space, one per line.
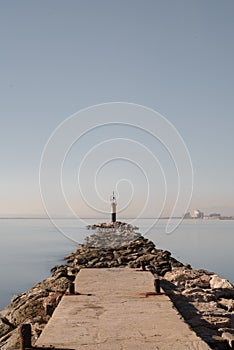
0, 0, 234, 217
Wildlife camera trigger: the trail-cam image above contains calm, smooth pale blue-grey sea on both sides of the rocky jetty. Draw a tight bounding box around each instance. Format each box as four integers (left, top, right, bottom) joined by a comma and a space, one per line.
0, 218, 234, 310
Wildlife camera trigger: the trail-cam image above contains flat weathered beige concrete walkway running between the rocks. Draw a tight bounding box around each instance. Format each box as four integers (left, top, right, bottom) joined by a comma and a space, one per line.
36, 268, 210, 350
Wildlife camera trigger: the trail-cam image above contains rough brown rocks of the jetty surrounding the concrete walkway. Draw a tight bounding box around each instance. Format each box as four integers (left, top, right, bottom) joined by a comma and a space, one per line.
0, 225, 234, 350
